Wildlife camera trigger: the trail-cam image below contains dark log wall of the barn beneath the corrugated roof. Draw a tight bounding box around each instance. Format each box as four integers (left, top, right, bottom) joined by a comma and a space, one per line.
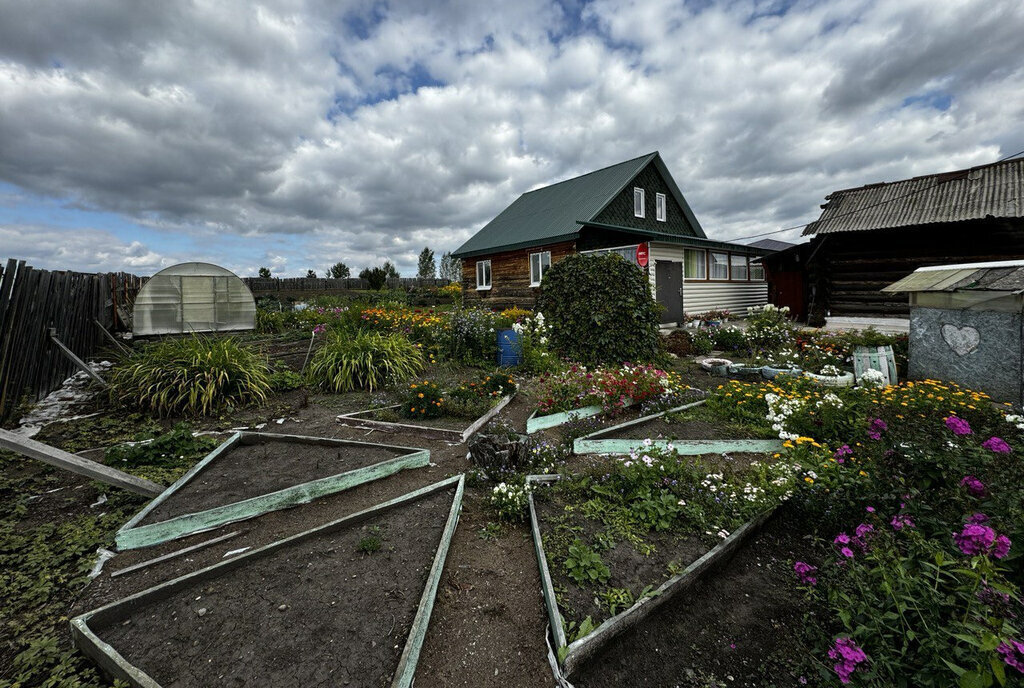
807, 218, 1024, 325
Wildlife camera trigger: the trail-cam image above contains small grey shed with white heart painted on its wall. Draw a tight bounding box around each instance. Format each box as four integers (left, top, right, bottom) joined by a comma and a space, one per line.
883, 260, 1024, 406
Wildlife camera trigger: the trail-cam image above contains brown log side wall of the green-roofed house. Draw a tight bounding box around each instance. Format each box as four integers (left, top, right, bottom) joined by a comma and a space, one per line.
462, 242, 575, 309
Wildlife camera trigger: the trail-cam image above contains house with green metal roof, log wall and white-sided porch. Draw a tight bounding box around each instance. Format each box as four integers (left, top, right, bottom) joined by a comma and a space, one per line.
453, 151, 768, 326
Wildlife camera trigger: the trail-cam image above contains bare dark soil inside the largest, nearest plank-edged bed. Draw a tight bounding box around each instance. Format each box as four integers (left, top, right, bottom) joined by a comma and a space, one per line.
95, 490, 455, 688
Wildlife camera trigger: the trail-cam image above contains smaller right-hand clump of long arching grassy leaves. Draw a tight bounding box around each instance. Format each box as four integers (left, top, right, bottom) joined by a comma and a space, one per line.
309, 333, 424, 392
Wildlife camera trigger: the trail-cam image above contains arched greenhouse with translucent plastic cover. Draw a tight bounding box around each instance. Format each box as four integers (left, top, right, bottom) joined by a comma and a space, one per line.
132, 263, 256, 336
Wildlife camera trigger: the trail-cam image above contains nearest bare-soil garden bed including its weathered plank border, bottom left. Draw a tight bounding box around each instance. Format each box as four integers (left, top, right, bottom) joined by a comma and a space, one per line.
72, 476, 464, 688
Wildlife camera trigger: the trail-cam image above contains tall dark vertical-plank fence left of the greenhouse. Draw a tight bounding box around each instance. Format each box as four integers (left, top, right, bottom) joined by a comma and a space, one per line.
0, 259, 142, 423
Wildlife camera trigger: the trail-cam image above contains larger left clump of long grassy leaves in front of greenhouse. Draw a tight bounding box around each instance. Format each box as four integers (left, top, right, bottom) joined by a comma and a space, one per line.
111, 335, 270, 416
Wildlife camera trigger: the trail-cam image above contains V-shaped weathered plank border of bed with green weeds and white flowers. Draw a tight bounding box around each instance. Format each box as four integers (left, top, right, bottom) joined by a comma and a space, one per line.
526, 475, 778, 685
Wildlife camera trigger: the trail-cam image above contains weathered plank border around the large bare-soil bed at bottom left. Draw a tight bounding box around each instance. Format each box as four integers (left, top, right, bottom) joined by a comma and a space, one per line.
71, 474, 465, 688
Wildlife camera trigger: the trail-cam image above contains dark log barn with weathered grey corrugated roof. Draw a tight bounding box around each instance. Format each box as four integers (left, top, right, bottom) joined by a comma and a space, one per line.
794, 159, 1024, 332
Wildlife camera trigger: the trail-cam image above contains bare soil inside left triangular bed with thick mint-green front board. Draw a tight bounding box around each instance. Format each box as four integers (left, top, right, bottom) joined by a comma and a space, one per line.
141, 440, 406, 524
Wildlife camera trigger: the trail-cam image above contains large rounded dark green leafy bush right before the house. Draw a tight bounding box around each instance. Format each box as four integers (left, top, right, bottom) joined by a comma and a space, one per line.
537, 254, 662, 366
